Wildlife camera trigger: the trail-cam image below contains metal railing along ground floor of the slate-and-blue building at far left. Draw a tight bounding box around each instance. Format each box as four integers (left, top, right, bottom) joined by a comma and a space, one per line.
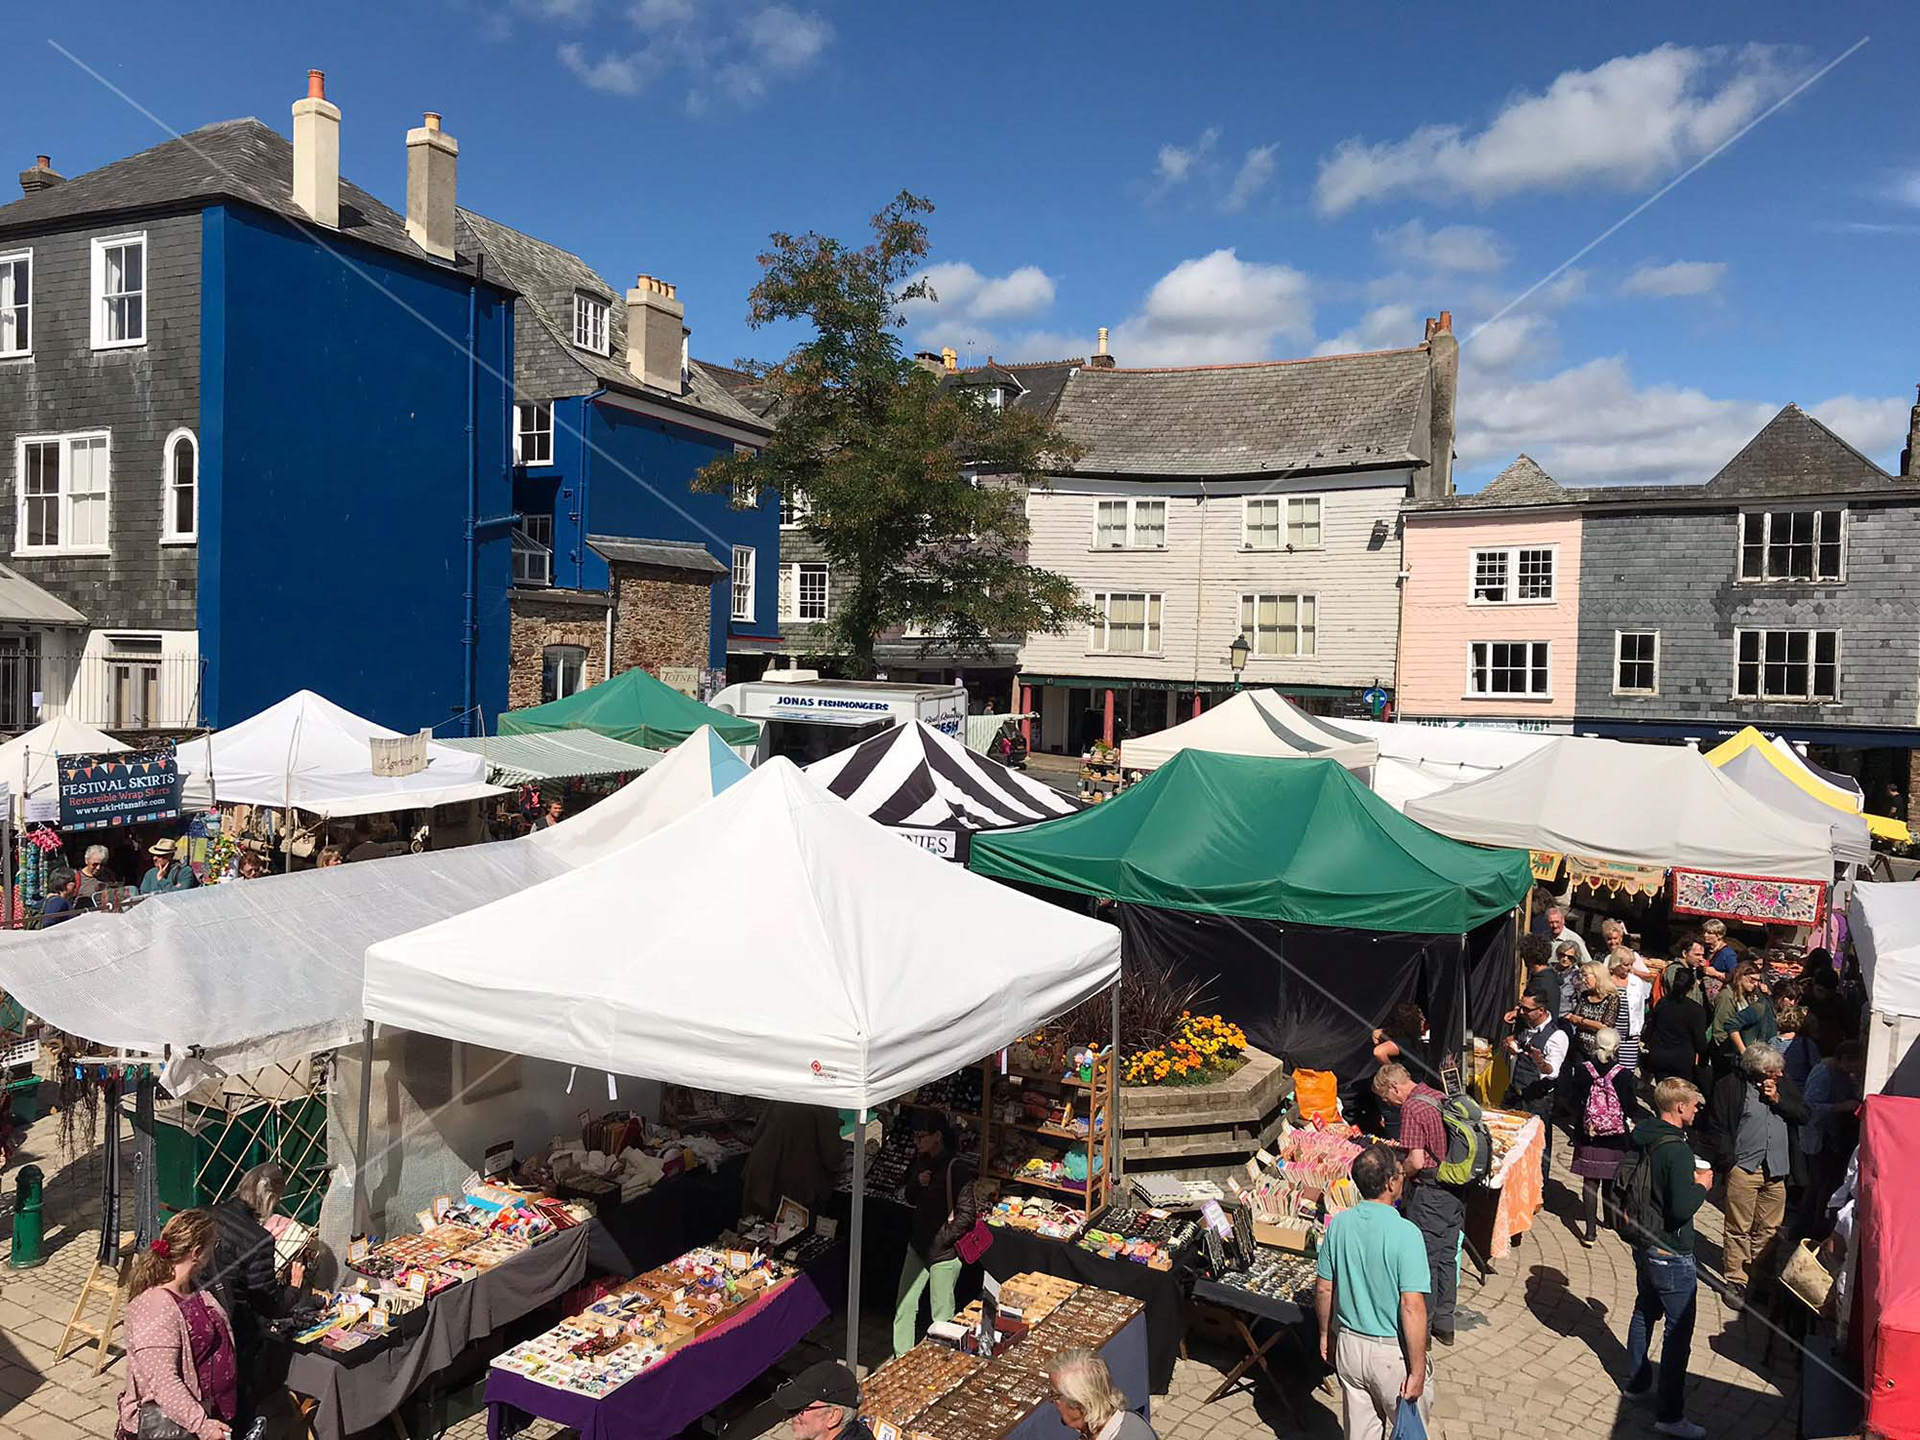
0, 643, 205, 733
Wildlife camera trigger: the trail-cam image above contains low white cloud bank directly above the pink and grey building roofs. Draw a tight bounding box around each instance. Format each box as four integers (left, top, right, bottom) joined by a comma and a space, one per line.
1455, 355, 1907, 484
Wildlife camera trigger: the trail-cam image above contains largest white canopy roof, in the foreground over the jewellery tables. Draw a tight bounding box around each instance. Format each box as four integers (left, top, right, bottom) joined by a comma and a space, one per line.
365, 758, 1119, 1108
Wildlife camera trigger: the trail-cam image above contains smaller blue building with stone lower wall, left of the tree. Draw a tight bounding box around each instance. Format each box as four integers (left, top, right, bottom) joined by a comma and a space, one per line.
459, 209, 781, 707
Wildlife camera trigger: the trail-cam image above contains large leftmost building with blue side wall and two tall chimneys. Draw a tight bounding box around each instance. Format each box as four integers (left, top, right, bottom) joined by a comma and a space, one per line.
0, 90, 515, 733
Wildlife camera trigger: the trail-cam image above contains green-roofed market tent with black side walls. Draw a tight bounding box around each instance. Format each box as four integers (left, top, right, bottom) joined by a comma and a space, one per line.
970, 751, 1532, 1081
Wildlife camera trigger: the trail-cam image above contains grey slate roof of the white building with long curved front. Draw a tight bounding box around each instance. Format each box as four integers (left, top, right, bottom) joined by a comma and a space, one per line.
1054, 346, 1428, 476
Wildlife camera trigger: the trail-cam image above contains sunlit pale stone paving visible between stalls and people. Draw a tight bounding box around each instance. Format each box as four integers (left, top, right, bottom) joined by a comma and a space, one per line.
0, 1098, 1799, 1440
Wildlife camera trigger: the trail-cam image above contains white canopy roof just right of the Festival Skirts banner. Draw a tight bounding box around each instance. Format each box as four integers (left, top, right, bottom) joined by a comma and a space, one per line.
179, 689, 501, 818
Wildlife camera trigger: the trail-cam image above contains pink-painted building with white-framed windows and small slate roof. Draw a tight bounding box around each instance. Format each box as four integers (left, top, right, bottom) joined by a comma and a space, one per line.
1396, 455, 1580, 730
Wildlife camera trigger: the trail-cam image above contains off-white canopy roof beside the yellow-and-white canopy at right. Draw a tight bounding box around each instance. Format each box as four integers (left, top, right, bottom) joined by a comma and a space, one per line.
1405, 735, 1834, 881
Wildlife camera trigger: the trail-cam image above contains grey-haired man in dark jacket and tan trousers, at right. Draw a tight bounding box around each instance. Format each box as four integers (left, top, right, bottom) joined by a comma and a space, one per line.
1701, 1044, 1812, 1309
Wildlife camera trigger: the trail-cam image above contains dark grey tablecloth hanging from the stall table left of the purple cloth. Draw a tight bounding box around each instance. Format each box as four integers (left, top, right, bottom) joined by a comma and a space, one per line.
286, 1225, 588, 1440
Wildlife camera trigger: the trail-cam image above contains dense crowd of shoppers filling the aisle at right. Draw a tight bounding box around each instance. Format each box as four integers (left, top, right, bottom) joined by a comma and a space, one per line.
1505, 906, 1866, 1436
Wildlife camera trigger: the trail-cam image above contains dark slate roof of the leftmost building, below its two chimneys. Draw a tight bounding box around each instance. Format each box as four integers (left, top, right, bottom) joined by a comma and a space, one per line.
0, 117, 468, 269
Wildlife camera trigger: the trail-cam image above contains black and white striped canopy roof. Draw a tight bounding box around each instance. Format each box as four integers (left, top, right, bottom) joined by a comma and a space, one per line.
806, 720, 1079, 833
